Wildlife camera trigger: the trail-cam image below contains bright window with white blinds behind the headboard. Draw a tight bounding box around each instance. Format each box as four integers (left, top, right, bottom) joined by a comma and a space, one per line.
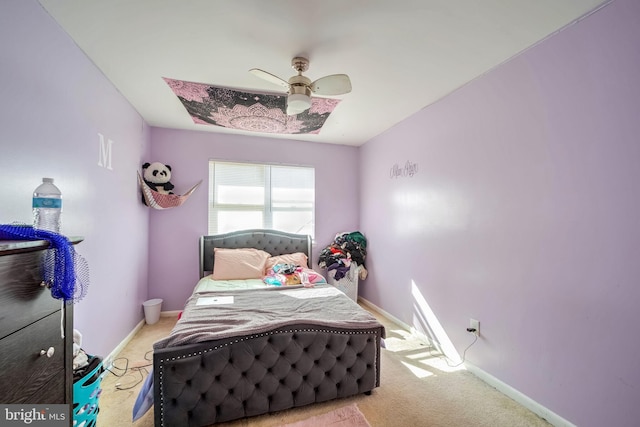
209, 160, 315, 237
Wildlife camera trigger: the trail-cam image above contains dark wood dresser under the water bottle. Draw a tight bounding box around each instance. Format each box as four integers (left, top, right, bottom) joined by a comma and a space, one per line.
0, 238, 82, 422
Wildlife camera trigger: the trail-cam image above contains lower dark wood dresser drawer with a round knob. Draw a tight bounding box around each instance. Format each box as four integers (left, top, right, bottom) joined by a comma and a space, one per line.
0, 311, 66, 404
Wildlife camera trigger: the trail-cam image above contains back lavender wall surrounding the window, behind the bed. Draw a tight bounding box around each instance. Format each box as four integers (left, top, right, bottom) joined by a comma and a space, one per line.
147, 128, 359, 310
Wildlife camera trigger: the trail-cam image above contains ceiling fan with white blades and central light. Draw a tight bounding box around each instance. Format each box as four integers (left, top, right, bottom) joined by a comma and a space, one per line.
249, 56, 351, 115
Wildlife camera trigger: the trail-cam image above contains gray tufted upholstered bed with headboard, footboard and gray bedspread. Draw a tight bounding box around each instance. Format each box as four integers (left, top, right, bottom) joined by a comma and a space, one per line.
152, 230, 385, 427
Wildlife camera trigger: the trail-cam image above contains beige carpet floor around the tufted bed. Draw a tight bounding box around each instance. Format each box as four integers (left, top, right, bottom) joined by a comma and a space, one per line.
97, 306, 550, 427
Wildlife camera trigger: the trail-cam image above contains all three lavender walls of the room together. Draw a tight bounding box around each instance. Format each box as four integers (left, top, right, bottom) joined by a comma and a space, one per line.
5, 0, 640, 426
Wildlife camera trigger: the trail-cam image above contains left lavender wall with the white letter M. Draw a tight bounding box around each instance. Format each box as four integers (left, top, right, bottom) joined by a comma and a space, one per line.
0, 0, 149, 355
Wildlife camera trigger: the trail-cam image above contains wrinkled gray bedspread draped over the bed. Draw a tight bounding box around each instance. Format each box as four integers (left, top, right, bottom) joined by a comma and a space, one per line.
153, 285, 381, 349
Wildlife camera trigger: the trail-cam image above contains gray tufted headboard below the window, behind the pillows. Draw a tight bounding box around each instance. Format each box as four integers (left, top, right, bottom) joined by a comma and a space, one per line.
200, 229, 311, 278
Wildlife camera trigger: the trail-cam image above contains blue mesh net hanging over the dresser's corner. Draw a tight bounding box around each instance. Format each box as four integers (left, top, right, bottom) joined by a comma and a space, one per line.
0, 224, 89, 304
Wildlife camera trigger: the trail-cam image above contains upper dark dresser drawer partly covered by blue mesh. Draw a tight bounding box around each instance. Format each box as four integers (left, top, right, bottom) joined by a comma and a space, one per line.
0, 251, 61, 340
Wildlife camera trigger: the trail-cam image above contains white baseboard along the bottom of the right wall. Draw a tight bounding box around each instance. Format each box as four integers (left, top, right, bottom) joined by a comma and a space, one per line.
358, 297, 576, 427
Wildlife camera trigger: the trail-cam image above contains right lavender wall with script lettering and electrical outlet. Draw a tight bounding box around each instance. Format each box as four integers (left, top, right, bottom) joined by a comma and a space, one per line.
360, 0, 640, 426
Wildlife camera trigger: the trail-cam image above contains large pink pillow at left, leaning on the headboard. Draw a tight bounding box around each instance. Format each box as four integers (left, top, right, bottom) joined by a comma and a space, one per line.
213, 248, 271, 280
